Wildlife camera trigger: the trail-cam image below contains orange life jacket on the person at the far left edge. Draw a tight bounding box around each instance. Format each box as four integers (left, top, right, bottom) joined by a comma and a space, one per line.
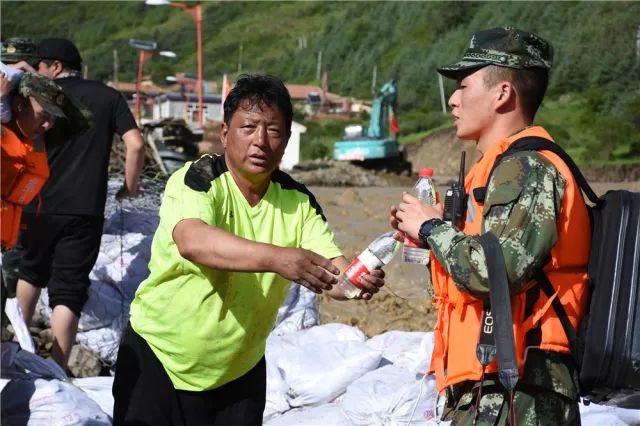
0, 125, 49, 249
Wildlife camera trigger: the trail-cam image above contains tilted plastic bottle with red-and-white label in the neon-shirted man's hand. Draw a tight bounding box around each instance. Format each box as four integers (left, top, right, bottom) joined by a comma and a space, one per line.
336, 231, 401, 299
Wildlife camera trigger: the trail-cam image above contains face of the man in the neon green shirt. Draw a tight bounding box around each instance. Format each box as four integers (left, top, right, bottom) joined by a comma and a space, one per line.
220, 99, 289, 182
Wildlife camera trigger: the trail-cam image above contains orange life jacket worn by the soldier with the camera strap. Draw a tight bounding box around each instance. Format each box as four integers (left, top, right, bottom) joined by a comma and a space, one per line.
430, 127, 591, 392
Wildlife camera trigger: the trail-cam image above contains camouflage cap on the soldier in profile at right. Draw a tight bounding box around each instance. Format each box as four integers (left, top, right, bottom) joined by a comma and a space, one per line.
437, 27, 553, 79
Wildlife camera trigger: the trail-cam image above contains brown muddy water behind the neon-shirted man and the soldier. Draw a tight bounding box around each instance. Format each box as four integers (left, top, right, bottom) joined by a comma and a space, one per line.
310, 182, 640, 336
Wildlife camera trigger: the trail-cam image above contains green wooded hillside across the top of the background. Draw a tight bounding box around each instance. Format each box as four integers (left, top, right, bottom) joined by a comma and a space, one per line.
0, 0, 640, 162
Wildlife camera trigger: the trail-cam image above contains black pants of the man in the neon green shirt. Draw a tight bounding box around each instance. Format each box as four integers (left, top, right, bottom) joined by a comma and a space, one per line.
113, 325, 267, 426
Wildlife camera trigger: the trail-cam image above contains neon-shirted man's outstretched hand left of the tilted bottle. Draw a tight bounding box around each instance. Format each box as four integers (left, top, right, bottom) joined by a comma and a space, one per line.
274, 248, 340, 294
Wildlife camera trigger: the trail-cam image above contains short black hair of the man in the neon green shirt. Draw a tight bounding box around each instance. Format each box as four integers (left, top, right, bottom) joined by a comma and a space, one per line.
224, 74, 293, 133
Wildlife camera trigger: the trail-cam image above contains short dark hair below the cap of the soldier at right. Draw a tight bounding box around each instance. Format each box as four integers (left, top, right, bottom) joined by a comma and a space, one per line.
484, 65, 549, 121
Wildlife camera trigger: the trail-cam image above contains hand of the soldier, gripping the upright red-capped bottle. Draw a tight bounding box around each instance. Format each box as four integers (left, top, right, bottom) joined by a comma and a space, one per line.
389, 192, 444, 240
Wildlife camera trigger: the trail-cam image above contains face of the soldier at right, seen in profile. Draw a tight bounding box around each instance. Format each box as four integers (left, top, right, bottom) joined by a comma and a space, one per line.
449, 68, 495, 141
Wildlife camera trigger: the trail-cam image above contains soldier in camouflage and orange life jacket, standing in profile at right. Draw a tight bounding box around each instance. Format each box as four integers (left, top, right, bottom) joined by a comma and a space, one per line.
391, 28, 590, 425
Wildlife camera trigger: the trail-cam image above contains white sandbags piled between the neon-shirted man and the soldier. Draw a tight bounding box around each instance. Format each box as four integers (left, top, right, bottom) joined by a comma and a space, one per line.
264, 324, 436, 425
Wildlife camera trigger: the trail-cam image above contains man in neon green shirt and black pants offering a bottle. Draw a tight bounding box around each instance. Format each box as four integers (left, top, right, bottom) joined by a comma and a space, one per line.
113, 76, 384, 426
